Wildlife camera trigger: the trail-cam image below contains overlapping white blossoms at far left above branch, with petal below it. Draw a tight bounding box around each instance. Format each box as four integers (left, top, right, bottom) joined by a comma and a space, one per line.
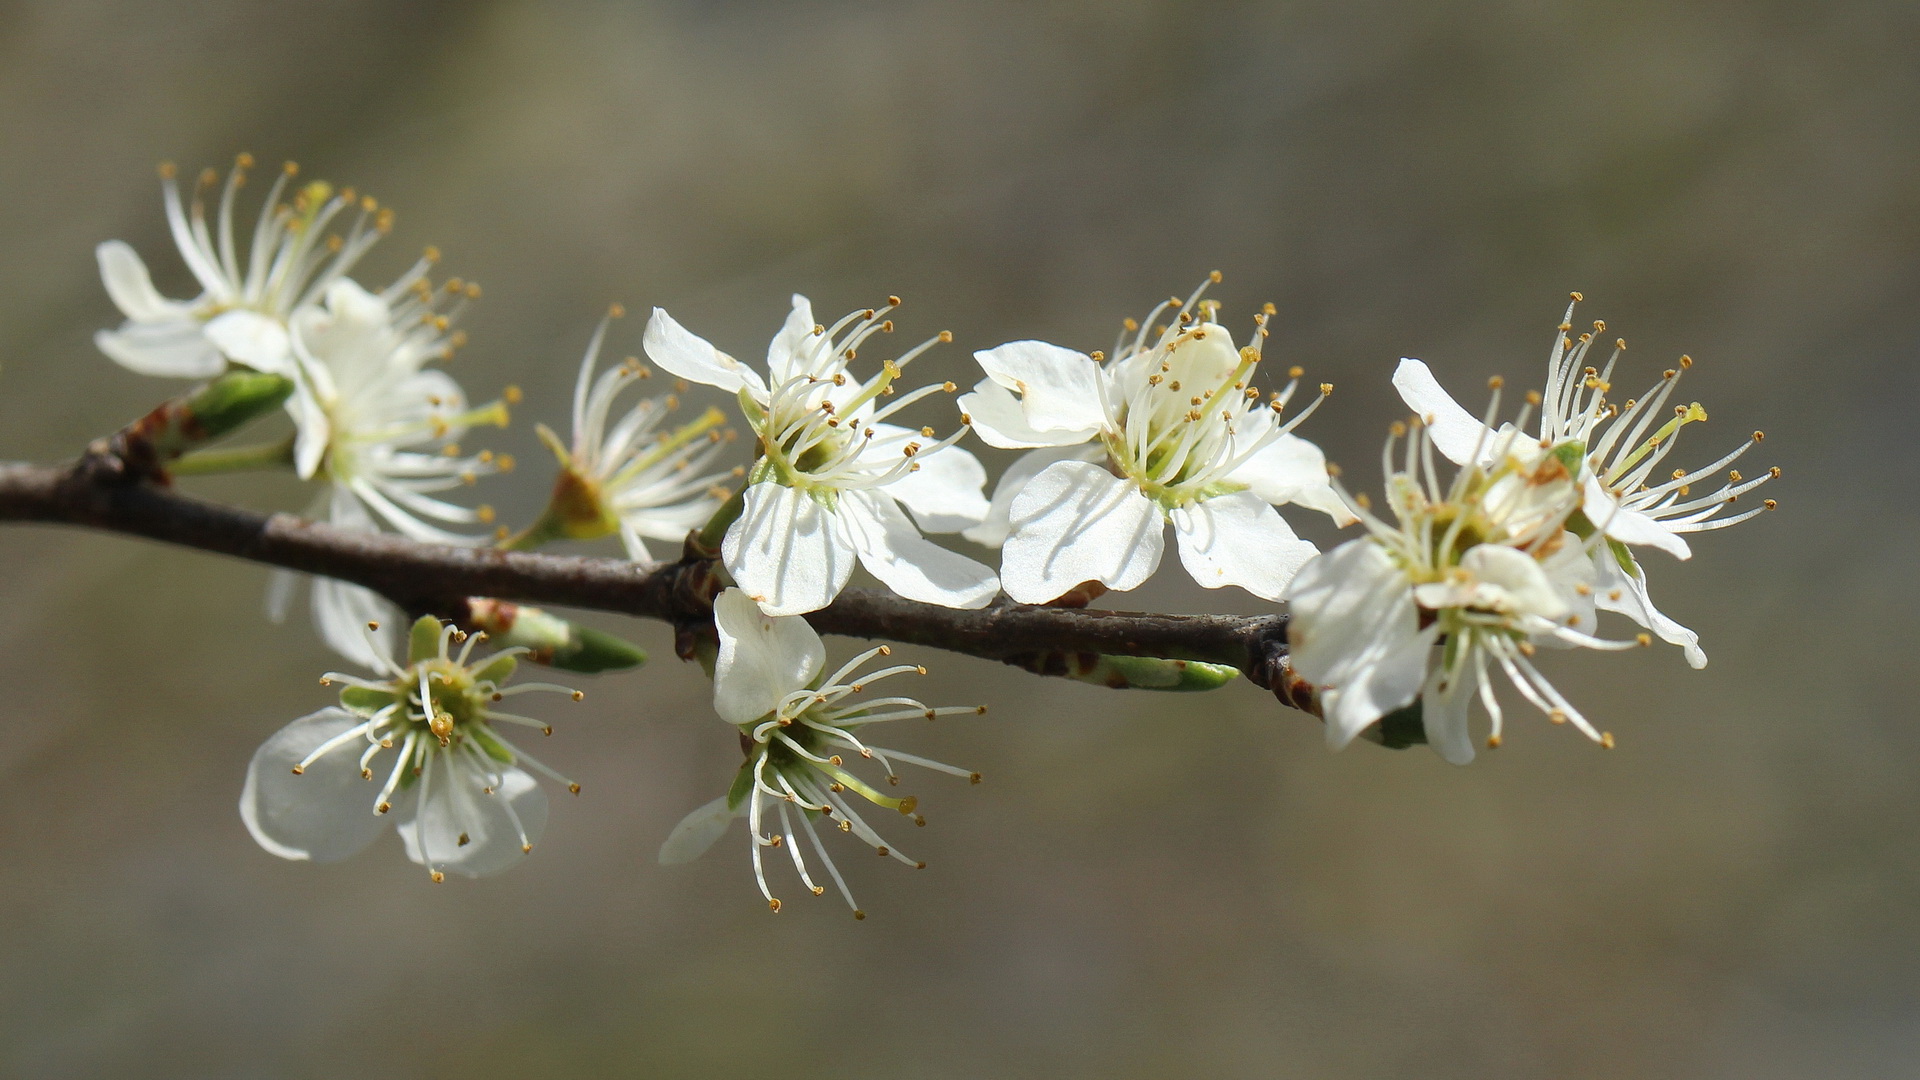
94, 154, 516, 665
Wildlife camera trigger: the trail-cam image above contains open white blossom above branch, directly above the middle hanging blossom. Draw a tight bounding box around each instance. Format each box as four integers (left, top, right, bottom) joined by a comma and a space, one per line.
645, 296, 1000, 615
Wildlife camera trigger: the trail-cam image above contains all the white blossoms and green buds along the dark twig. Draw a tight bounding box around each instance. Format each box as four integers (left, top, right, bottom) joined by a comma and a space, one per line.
82, 156, 1780, 917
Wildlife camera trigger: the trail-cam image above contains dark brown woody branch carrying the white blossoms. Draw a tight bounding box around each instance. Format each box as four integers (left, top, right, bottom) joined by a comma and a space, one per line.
0, 448, 1313, 687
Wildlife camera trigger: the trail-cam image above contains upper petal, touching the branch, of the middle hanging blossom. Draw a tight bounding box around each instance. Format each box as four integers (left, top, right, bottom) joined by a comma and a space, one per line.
714, 588, 828, 724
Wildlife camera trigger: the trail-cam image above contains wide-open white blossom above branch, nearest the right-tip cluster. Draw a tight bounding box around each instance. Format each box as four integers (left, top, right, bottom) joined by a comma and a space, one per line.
960, 275, 1352, 603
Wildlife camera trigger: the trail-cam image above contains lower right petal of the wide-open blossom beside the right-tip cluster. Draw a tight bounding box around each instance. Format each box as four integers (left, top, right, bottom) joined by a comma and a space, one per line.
1169, 492, 1319, 600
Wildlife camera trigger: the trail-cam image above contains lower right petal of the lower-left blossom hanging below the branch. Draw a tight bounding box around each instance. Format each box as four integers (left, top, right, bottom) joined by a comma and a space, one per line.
394, 751, 547, 878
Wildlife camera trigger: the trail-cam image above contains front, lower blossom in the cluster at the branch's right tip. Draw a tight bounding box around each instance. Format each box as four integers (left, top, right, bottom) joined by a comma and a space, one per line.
1286, 396, 1647, 765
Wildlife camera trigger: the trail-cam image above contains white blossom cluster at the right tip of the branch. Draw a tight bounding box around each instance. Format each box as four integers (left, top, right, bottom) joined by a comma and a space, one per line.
1286, 294, 1780, 763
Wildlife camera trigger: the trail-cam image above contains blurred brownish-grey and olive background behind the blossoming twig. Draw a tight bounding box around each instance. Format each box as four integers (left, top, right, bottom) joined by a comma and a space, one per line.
0, 0, 1920, 1080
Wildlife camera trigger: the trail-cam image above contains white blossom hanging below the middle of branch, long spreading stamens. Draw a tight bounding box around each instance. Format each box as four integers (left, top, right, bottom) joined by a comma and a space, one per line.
660, 588, 987, 919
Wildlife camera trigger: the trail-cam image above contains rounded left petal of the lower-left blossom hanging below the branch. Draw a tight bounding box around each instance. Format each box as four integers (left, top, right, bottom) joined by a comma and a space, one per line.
240, 707, 386, 863
